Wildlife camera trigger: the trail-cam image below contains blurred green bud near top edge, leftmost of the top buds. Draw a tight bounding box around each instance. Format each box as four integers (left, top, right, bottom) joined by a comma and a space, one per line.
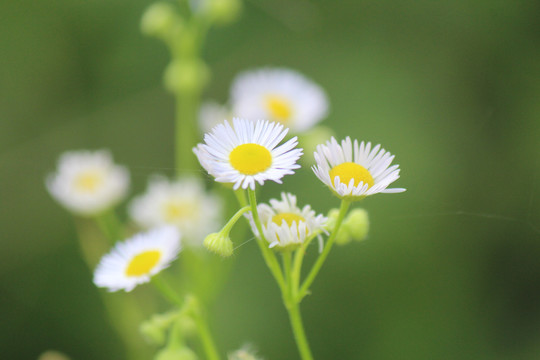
141, 2, 181, 39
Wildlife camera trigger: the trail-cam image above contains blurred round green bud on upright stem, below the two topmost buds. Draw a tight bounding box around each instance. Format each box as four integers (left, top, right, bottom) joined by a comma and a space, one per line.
164, 59, 210, 93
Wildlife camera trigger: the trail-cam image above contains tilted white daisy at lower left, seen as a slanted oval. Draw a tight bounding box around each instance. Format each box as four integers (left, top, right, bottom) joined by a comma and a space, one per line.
94, 226, 181, 291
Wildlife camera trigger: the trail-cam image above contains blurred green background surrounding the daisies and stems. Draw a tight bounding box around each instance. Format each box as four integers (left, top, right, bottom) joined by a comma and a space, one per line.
0, 0, 540, 360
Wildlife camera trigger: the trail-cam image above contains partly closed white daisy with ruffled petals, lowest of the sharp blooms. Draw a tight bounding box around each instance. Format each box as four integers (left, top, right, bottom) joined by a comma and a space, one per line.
246, 193, 328, 249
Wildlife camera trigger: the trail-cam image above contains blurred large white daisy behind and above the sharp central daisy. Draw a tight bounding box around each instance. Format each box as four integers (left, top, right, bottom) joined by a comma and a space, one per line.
231, 68, 328, 133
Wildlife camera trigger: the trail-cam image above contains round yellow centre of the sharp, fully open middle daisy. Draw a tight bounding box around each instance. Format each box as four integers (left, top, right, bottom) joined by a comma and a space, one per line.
229, 143, 272, 175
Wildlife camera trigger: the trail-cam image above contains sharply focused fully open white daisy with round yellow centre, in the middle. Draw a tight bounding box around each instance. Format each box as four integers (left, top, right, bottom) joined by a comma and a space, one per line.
193, 119, 302, 190
